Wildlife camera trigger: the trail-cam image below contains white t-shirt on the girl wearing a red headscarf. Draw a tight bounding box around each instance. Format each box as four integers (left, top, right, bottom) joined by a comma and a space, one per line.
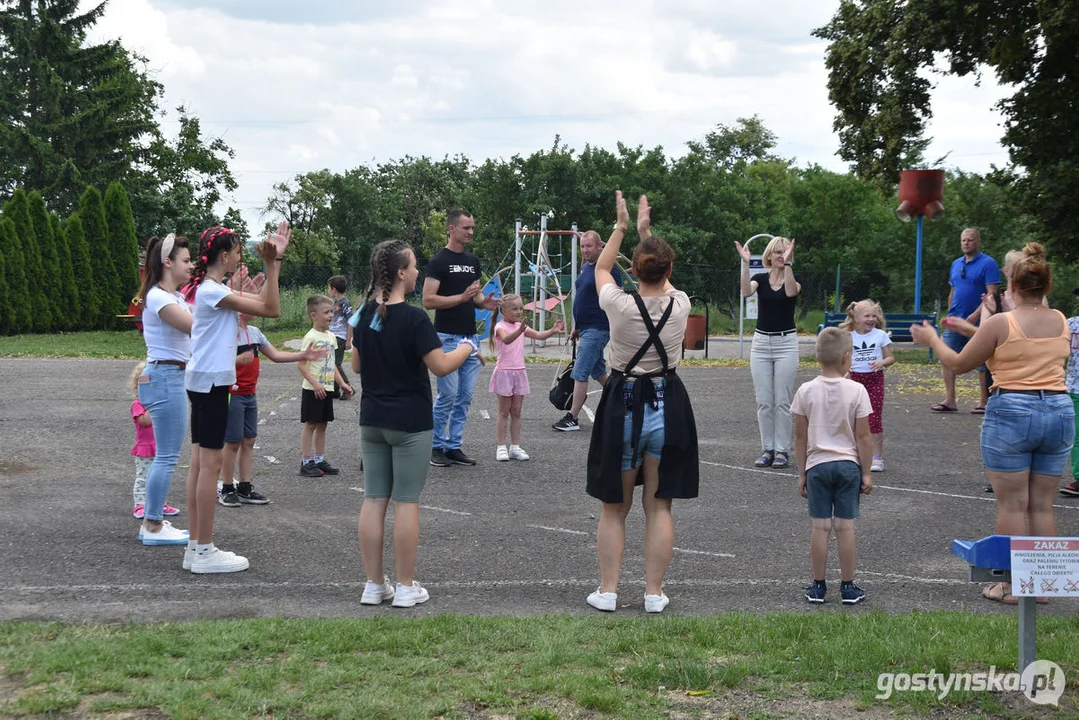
183, 277, 240, 393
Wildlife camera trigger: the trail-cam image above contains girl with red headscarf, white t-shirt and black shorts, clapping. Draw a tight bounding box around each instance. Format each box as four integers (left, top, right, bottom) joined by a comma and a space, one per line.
183, 222, 289, 574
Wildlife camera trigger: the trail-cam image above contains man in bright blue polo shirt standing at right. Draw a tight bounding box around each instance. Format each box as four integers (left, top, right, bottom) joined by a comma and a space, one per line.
931, 228, 1000, 413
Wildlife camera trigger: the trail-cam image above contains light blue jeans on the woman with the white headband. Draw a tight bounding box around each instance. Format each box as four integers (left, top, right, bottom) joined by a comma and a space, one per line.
138, 365, 188, 520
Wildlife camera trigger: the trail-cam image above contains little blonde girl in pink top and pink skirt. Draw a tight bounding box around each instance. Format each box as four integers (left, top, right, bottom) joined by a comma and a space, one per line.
489, 293, 565, 461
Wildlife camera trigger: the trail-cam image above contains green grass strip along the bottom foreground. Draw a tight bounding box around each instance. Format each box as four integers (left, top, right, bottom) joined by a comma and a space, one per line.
0, 612, 1079, 720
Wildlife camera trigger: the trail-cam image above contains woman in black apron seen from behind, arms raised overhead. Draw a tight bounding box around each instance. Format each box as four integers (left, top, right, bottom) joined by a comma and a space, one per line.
587, 192, 699, 612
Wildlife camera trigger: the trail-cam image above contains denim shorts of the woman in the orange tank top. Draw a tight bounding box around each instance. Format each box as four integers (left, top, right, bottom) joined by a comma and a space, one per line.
982, 393, 1076, 476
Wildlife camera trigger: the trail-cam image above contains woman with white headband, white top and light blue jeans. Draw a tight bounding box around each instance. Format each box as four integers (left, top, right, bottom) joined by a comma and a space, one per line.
136, 234, 191, 545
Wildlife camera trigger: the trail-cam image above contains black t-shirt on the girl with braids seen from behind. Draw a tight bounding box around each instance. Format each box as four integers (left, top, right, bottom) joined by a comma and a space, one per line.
353, 301, 442, 433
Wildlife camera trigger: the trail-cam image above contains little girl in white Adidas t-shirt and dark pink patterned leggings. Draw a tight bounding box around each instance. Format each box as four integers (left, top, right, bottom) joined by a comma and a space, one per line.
839, 300, 896, 473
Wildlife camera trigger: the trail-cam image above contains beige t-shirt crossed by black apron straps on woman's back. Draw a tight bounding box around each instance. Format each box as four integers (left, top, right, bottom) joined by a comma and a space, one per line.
600, 284, 689, 375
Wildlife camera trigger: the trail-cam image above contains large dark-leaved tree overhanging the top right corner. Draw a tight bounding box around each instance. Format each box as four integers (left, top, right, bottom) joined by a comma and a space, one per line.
815, 0, 1079, 259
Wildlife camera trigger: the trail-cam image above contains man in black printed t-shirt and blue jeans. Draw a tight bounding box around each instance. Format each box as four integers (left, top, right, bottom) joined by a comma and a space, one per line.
423, 209, 498, 467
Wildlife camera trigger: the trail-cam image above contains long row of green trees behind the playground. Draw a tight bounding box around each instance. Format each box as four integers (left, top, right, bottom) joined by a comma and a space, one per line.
256, 118, 1074, 312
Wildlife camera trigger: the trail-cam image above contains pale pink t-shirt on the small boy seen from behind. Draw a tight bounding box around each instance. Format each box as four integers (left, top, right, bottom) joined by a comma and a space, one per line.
791, 376, 873, 470
